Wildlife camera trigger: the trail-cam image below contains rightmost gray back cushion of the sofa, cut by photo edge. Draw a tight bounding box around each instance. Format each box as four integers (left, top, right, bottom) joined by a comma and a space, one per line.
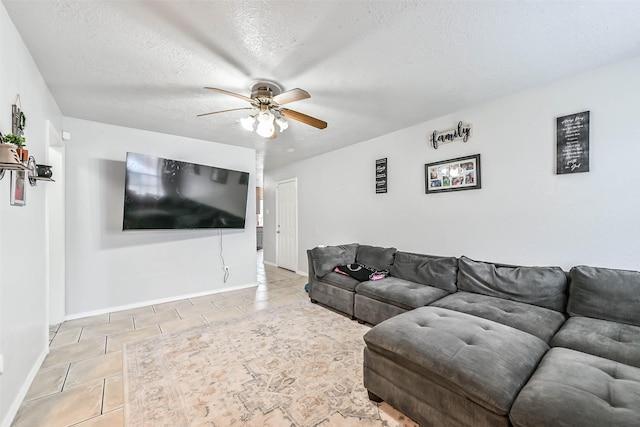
567, 265, 640, 326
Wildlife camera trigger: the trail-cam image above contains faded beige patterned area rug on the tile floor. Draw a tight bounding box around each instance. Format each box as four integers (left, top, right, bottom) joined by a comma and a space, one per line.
123, 302, 417, 427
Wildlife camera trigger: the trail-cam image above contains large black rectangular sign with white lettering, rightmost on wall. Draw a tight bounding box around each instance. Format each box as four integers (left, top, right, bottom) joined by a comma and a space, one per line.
556, 111, 589, 174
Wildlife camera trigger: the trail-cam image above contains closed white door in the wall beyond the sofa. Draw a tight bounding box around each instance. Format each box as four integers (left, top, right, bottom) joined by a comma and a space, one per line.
276, 179, 298, 271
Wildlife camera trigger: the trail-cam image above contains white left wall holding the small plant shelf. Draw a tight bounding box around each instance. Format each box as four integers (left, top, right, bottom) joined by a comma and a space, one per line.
0, 4, 62, 426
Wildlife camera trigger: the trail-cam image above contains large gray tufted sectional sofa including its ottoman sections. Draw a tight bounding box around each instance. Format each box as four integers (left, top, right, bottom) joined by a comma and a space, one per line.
308, 244, 640, 427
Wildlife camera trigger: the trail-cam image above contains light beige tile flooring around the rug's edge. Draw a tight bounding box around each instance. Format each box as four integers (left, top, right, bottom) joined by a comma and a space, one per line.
11, 251, 307, 427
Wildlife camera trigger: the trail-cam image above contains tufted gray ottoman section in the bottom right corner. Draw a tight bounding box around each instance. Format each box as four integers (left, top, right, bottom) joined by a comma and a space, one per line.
511, 348, 640, 427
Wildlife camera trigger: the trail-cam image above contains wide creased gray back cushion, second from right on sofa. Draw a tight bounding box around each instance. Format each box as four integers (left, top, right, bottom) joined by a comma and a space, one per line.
458, 257, 567, 312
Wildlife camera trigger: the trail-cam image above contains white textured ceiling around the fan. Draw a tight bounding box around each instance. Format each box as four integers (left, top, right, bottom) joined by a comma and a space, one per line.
3, 0, 640, 176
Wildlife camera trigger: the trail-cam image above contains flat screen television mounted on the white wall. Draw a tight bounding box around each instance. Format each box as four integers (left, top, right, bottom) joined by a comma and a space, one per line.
122, 153, 249, 230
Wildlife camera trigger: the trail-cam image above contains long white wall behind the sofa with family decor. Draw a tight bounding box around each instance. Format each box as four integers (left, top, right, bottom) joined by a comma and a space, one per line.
264, 59, 640, 271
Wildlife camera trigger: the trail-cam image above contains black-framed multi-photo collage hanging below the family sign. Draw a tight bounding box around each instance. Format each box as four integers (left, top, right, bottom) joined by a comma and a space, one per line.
424, 154, 482, 194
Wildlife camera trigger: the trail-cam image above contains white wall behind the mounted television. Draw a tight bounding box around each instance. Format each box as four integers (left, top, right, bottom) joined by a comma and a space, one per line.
64, 117, 256, 317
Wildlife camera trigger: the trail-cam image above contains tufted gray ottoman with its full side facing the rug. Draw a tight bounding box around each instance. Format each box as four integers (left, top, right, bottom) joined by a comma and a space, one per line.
364, 307, 549, 427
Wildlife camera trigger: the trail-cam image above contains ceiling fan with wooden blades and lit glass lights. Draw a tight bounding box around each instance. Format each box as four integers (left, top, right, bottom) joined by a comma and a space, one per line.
197, 81, 327, 139
